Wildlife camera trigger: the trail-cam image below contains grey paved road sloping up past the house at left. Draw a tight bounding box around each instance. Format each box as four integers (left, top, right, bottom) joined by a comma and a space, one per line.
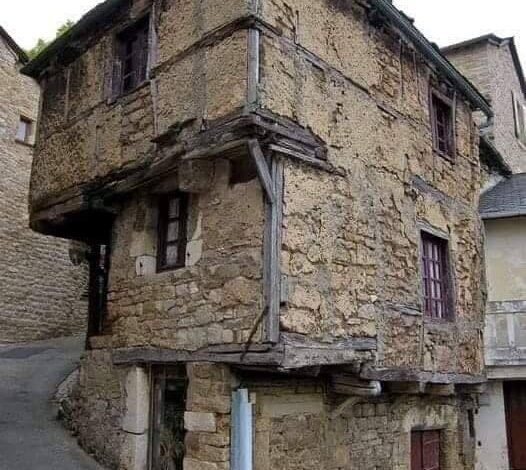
0, 338, 103, 470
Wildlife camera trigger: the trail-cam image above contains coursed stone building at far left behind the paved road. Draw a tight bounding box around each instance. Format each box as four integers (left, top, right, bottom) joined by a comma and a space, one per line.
0, 27, 87, 344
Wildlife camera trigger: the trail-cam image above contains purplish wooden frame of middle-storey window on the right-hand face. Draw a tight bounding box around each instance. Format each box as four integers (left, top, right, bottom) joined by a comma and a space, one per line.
419, 230, 455, 322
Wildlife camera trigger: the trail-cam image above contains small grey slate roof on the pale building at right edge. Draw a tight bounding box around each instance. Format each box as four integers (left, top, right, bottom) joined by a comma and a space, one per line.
479, 173, 526, 219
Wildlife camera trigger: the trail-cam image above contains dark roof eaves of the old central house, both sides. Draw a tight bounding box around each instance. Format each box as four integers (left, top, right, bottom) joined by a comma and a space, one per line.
22, 0, 493, 116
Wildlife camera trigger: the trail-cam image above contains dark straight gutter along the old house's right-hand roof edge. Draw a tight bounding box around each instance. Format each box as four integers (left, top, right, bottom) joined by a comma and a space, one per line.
370, 0, 493, 118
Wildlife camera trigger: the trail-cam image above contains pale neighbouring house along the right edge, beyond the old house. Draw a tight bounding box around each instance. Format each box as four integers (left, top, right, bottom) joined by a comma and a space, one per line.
444, 35, 526, 470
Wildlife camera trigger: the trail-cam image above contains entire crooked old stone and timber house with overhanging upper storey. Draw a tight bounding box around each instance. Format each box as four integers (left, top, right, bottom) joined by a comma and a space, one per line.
24, 0, 498, 470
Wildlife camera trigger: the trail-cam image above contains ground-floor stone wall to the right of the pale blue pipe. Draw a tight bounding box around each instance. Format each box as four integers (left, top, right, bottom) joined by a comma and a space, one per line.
249, 378, 475, 470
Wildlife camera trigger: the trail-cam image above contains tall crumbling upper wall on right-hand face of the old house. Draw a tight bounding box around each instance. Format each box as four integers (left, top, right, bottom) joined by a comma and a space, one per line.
260, 0, 484, 374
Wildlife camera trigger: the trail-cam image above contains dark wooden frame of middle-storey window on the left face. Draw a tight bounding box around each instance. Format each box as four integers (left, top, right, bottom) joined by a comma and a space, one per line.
157, 191, 190, 272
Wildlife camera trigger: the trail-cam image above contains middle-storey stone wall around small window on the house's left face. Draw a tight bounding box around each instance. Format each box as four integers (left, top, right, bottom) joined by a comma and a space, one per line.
107, 160, 263, 350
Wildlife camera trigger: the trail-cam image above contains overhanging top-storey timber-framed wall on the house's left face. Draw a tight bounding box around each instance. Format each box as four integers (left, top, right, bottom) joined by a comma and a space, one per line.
31, 0, 254, 207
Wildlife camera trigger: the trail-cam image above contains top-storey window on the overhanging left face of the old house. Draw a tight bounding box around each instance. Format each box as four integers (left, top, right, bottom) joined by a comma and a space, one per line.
114, 17, 149, 95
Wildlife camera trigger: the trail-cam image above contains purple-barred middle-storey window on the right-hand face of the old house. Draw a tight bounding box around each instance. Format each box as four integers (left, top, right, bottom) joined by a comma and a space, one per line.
422, 232, 452, 319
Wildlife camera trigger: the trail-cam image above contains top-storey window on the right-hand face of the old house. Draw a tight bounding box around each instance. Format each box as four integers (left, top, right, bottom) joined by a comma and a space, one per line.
431, 92, 455, 157
